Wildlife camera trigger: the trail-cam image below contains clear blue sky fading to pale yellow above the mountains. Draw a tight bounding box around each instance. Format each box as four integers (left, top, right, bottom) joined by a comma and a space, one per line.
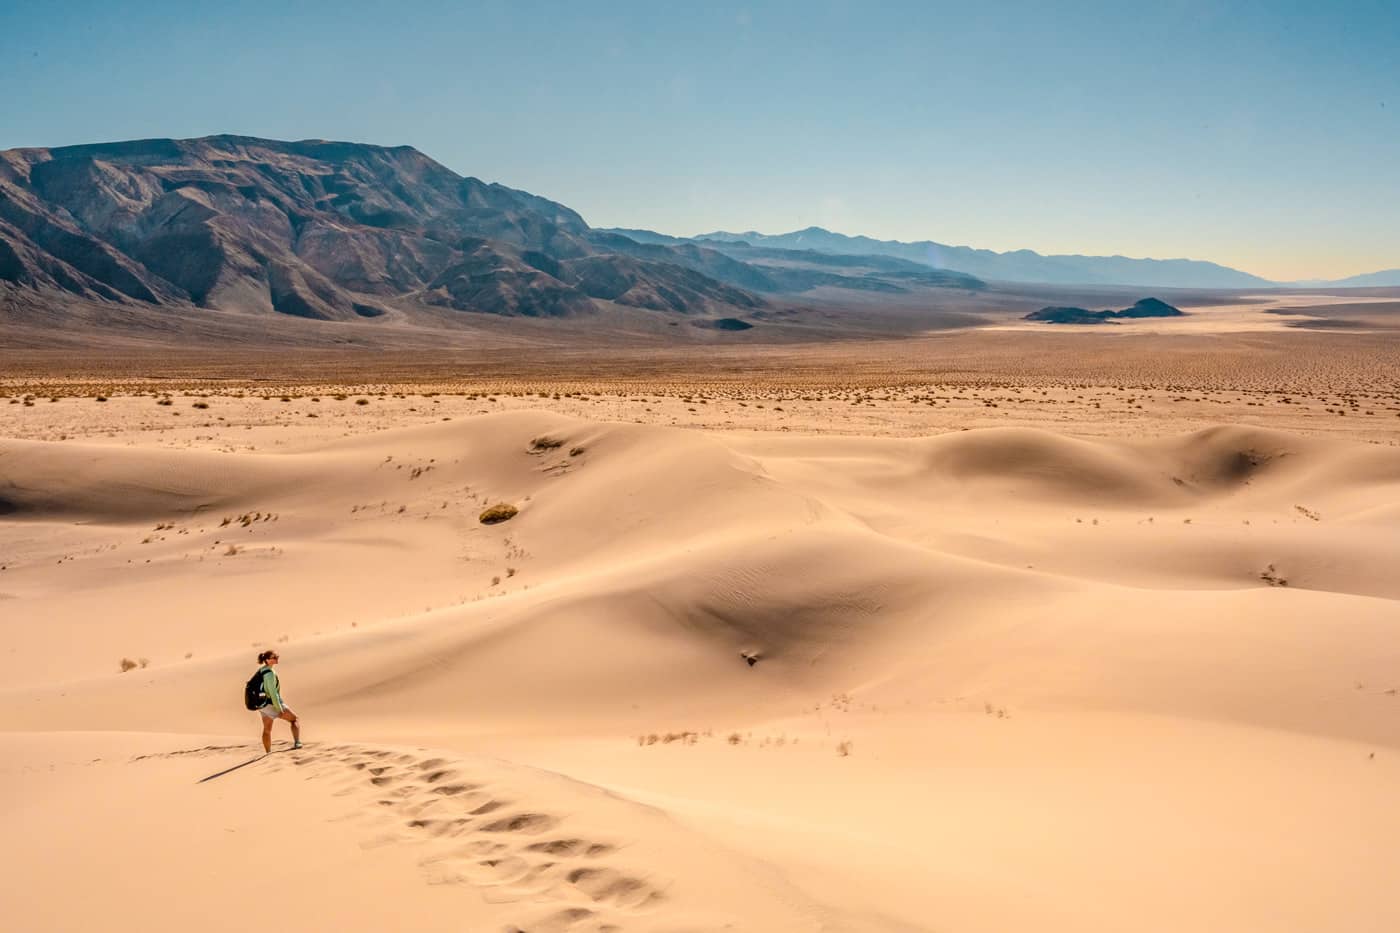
0, 0, 1400, 279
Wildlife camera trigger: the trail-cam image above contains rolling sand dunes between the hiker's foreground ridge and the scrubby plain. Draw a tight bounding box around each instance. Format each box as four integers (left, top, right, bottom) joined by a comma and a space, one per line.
0, 413, 1400, 741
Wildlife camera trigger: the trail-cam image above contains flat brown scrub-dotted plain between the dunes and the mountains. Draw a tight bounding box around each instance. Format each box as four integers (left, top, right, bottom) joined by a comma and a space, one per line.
8, 319, 1400, 457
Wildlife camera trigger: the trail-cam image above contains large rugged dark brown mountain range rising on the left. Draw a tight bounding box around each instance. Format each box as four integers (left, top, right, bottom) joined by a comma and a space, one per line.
0, 136, 981, 321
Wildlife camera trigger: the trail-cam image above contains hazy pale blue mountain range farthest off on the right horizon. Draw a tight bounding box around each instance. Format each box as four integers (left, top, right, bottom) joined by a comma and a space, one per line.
613, 227, 1400, 289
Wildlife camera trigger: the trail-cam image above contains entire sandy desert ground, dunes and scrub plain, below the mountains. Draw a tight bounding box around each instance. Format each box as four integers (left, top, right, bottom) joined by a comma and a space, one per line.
0, 321, 1400, 933
